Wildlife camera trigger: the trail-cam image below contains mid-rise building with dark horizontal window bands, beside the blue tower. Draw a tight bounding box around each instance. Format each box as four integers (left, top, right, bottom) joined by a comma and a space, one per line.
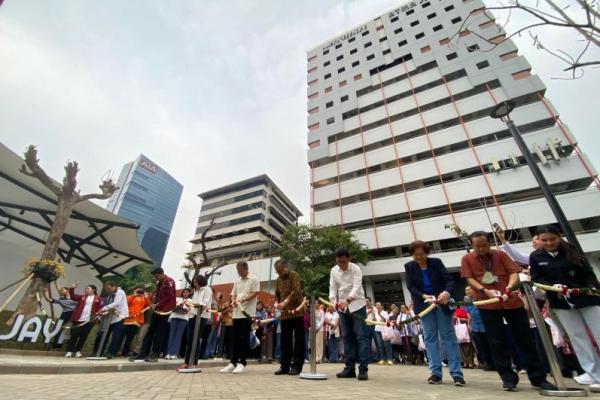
191, 175, 302, 264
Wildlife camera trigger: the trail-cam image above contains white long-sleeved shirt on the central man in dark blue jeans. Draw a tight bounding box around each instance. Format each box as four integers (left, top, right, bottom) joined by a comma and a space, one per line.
329, 263, 367, 312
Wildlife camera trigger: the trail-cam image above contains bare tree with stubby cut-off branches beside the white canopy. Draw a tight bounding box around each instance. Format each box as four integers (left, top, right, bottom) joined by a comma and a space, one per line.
7, 146, 117, 325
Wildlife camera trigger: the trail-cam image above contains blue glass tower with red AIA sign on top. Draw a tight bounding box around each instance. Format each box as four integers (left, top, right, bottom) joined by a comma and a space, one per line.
106, 154, 183, 266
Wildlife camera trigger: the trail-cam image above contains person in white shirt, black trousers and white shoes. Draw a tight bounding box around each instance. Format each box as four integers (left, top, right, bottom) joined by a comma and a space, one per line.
221, 261, 260, 374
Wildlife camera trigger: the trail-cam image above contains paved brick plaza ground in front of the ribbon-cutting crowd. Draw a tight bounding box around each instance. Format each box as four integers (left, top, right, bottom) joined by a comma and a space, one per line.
0, 364, 600, 400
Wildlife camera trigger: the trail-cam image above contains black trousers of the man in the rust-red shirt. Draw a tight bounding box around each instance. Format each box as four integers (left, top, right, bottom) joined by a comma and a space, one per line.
480, 308, 546, 384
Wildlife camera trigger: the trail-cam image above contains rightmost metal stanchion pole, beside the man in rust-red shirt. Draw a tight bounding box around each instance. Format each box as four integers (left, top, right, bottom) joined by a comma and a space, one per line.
522, 285, 588, 397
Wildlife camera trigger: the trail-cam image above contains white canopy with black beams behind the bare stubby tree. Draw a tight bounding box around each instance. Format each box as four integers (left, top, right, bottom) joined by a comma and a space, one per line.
0, 143, 152, 276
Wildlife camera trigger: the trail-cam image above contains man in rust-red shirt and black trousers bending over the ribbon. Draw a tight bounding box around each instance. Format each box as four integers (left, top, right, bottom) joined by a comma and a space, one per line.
460, 231, 556, 392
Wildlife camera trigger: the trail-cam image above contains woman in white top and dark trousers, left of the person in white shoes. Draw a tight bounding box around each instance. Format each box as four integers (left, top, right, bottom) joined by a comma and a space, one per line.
179, 275, 212, 369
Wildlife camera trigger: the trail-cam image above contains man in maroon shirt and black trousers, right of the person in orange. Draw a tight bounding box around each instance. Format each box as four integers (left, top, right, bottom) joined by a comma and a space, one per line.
129, 268, 177, 362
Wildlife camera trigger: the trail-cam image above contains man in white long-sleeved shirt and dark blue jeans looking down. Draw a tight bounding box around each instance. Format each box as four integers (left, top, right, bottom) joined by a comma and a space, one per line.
329, 249, 371, 381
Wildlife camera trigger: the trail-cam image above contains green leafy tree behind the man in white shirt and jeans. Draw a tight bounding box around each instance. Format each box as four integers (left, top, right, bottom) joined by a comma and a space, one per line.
279, 225, 368, 296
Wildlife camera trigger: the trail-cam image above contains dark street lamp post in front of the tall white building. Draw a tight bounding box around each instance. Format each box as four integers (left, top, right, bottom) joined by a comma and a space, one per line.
490, 100, 583, 254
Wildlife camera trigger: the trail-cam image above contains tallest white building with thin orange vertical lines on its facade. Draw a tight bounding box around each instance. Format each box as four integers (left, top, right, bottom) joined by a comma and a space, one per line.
307, 0, 600, 303
